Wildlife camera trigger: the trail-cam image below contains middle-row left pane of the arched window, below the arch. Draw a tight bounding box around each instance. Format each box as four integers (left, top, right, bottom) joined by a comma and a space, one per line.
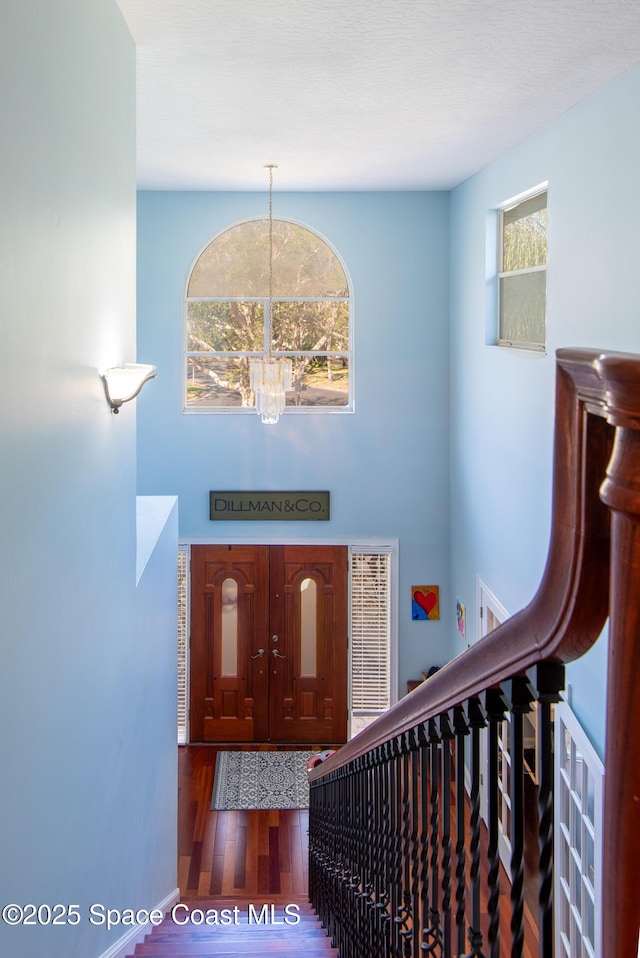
187, 303, 264, 353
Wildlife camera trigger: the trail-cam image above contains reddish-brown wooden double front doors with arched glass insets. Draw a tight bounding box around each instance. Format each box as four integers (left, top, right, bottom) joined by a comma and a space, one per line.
190, 545, 347, 744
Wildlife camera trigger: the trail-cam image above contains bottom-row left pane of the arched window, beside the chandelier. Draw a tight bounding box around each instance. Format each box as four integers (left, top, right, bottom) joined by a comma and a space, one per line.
187, 356, 253, 406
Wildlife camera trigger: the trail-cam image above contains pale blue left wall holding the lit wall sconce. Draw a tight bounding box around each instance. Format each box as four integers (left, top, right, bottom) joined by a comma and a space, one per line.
0, 0, 177, 958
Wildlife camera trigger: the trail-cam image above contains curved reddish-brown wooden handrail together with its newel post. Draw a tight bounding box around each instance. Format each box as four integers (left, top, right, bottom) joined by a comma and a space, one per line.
309, 349, 640, 958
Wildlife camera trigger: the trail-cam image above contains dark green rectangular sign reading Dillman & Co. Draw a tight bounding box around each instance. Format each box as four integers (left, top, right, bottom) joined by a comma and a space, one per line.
209, 492, 330, 522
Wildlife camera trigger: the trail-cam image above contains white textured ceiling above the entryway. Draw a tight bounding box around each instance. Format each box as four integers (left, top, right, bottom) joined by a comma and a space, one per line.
118, 0, 640, 190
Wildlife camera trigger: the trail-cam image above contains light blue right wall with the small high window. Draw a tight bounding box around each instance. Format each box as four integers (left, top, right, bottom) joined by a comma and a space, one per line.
450, 68, 640, 754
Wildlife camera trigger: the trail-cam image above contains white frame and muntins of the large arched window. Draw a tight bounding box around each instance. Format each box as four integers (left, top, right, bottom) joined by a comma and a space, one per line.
180, 215, 356, 416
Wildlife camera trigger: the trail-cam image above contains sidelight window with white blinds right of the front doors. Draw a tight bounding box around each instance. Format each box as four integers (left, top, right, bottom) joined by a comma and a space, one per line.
351, 551, 391, 715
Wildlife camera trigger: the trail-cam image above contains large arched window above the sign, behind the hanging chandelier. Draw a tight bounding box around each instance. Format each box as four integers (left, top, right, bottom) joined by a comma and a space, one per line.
184, 219, 353, 413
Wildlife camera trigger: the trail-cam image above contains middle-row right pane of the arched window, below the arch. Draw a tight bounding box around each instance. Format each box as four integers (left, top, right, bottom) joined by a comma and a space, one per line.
271, 302, 349, 352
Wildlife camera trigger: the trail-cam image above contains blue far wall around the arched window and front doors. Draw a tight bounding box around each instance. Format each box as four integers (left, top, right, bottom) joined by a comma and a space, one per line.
138, 192, 452, 687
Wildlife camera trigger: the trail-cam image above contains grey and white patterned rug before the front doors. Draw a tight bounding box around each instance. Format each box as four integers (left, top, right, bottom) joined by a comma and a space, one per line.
211, 752, 315, 810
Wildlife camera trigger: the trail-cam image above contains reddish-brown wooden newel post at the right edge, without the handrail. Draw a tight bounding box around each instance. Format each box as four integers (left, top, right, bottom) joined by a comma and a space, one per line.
596, 355, 640, 958
